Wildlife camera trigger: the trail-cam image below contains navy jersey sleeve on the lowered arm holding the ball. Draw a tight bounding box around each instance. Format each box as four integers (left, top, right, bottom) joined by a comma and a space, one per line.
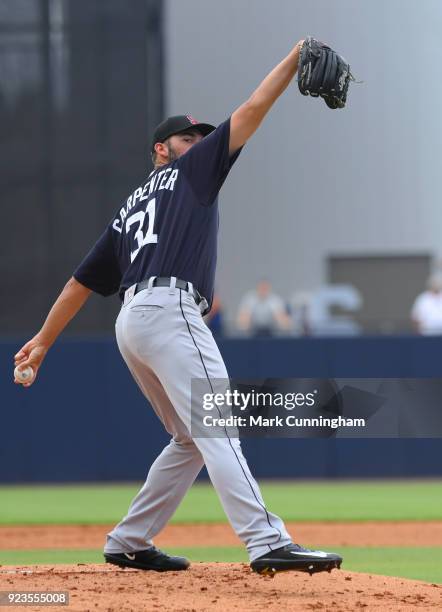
73, 226, 122, 296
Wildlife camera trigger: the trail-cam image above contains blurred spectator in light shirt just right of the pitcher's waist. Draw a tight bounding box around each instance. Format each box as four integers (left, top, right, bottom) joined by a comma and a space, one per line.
237, 280, 291, 336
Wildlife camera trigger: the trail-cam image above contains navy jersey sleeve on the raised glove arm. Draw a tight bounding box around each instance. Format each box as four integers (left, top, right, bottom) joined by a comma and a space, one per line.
179, 117, 242, 206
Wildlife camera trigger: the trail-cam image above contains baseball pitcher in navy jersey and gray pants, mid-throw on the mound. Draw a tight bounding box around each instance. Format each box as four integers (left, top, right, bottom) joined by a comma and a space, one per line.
15, 38, 348, 574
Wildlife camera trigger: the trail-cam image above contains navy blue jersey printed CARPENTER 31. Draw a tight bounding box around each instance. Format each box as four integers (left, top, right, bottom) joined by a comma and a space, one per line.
73, 119, 240, 306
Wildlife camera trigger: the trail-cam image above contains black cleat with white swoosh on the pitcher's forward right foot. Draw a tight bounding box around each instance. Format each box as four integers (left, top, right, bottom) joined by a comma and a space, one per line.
250, 544, 342, 576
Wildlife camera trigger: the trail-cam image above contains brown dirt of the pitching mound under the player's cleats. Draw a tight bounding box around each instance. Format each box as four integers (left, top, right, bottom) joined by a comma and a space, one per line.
0, 563, 442, 612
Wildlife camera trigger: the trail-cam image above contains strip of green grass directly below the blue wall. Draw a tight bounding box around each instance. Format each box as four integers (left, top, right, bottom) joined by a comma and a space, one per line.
0, 481, 442, 525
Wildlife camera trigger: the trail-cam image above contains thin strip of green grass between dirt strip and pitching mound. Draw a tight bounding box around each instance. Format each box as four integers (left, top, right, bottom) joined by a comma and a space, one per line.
0, 547, 442, 583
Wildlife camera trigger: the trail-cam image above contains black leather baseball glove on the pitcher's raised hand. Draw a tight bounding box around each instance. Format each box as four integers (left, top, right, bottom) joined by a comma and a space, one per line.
298, 36, 355, 108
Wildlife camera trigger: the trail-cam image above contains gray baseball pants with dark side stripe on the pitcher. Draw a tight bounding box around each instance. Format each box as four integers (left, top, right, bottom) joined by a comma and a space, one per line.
104, 282, 291, 561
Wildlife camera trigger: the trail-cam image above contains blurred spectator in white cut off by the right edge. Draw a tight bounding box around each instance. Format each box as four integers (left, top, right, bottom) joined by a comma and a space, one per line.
411, 273, 442, 336
